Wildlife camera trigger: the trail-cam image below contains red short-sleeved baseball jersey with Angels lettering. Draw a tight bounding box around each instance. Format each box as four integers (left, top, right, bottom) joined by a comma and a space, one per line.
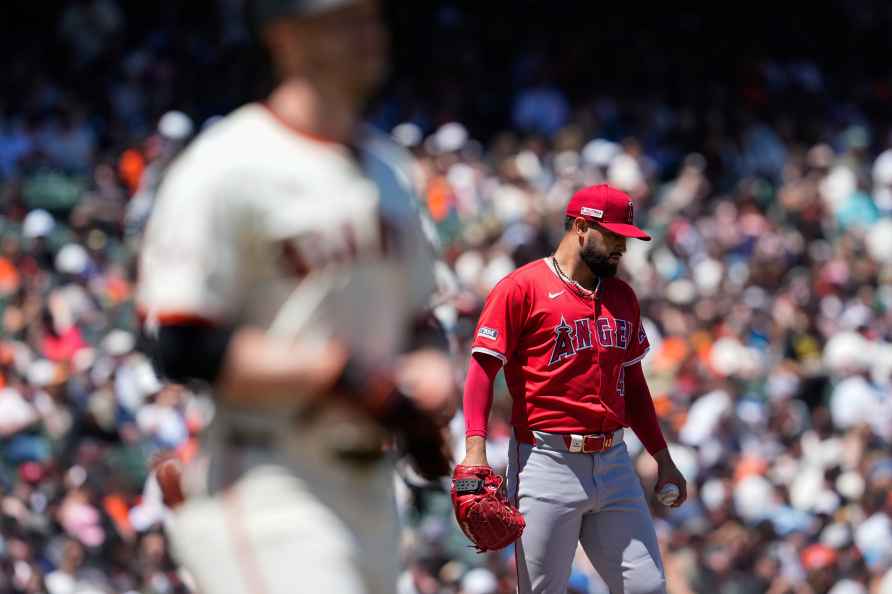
471, 257, 650, 433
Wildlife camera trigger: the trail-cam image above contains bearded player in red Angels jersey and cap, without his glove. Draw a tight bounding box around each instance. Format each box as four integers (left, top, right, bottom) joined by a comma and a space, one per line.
456, 185, 686, 594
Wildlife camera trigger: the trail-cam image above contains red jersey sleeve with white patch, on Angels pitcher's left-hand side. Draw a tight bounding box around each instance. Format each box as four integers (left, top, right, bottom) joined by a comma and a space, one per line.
471, 278, 528, 365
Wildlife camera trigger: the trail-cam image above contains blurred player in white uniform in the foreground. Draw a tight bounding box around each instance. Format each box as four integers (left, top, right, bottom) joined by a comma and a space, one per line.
139, 0, 452, 594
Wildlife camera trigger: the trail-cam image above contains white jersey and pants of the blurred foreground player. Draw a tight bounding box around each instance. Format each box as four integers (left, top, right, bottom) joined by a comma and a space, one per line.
140, 104, 434, 594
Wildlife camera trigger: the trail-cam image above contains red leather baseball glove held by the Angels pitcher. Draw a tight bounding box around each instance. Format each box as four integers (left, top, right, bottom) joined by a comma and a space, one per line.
452, 465, 526, 553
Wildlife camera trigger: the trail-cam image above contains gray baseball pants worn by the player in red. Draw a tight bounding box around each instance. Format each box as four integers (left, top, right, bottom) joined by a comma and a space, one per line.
507, 431, 666, 594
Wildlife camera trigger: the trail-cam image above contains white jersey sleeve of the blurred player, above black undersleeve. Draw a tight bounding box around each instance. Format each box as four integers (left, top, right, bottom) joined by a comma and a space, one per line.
138, 153, 250, 325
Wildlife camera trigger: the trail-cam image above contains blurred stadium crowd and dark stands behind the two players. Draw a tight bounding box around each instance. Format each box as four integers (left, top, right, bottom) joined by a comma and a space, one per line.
0, 0, 892, 594
